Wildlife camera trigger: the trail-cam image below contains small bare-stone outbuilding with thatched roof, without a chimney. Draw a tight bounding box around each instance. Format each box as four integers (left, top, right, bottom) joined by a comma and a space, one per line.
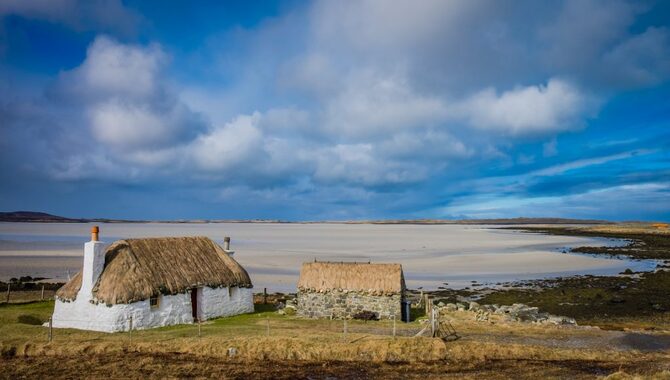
297, 262, 405, 320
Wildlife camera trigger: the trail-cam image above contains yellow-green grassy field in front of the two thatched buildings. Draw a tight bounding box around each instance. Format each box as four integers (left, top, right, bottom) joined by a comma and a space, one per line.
0, 302, 670, 378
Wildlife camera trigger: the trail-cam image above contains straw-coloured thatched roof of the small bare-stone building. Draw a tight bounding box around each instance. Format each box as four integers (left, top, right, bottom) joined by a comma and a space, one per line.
298, 262, 405, 294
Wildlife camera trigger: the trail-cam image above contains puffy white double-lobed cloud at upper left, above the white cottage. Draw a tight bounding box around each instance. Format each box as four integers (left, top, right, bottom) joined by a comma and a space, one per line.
56, 36, 204, 153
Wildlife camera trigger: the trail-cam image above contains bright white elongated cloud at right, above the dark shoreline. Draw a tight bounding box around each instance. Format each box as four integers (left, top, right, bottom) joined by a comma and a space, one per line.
456, 79, 589, 135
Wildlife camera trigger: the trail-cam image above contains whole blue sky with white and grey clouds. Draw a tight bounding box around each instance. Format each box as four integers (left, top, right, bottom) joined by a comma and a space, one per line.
0, 0, 670, 221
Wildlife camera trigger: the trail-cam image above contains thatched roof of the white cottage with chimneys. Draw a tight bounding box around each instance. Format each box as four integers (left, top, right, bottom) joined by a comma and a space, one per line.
56, 237, 252, 305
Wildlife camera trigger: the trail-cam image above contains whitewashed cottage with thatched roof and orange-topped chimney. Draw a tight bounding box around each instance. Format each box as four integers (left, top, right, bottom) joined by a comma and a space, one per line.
53, 227, 254, 332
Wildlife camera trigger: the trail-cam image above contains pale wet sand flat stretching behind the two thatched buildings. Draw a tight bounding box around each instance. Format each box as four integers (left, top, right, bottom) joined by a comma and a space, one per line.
0, 223, 655, 291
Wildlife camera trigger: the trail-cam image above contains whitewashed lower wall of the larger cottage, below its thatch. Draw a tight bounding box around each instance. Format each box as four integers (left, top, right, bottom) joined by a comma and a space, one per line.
53, 287, 254, 332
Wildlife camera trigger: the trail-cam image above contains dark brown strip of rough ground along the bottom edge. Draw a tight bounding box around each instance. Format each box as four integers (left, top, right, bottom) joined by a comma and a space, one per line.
0, 353, 670, 379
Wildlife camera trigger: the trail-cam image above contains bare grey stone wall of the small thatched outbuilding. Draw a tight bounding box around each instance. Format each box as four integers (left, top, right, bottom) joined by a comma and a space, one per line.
297, 291, 402, 321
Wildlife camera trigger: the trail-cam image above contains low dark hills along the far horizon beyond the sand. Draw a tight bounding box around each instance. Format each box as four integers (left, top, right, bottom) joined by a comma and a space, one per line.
0, 211, 613, 225
